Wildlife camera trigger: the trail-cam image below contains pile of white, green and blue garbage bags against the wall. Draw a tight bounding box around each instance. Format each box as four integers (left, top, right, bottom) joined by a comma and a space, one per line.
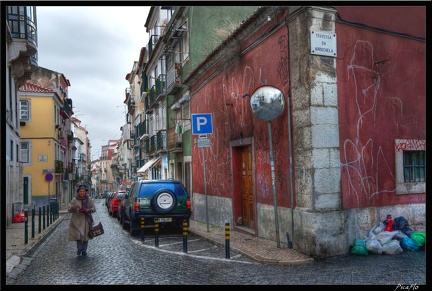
351, 215, 426, 256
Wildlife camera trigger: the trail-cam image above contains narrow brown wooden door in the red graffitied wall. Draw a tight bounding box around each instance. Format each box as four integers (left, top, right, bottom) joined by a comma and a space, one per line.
240, 145, 255, 229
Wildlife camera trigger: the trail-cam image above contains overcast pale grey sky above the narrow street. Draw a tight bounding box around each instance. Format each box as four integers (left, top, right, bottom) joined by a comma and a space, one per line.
37, 2, 149, 160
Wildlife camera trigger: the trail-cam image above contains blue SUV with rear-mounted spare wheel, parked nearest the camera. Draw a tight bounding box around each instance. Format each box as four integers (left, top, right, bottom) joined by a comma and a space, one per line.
120, 180, 191, 235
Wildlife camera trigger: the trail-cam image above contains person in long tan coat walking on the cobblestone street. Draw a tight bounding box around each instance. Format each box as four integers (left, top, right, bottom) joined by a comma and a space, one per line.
68, 184, 96, 256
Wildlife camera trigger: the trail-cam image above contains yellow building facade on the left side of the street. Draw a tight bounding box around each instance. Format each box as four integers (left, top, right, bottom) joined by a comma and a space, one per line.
18, 82, 64, 211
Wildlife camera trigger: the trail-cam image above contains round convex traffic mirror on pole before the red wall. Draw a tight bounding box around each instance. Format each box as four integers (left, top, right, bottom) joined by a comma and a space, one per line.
250, 85, 285, 120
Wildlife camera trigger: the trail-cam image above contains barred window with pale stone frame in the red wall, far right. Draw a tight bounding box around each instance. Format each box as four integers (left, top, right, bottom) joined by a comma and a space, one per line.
395, 139, 426, 194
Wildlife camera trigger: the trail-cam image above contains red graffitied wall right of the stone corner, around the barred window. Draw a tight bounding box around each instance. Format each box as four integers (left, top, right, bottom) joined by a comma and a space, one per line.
336, 7, 426, 208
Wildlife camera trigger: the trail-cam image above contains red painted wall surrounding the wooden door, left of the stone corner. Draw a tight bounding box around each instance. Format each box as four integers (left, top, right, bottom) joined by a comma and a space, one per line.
191, 27, 290, 207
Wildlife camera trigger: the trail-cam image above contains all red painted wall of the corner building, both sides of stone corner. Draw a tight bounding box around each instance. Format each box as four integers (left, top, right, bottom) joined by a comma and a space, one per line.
190, 7, 426, 212
